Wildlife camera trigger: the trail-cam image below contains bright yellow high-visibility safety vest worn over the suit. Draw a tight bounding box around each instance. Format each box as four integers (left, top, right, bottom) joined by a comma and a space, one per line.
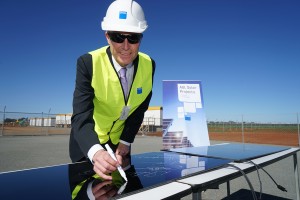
89, 46, 152, 144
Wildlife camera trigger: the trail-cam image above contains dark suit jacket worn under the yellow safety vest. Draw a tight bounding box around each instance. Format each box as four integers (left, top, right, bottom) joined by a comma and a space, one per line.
69, 48, 155, 162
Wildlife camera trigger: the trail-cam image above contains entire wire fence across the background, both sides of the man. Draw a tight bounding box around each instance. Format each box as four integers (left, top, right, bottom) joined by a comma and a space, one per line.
0, 111, 300, 146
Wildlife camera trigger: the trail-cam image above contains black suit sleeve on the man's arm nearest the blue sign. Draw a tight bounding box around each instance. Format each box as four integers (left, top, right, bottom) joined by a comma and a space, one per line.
120, 59, 156, 143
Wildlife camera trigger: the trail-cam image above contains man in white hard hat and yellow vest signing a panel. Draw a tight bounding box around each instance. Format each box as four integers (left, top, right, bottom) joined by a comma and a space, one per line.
70, 0, 155, 180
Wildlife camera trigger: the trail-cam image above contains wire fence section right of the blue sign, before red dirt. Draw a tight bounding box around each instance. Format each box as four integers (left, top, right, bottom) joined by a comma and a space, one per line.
207, 113, 300, 146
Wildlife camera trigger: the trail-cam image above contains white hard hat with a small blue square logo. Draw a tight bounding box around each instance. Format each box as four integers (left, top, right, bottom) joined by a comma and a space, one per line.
101, 0, 148, 33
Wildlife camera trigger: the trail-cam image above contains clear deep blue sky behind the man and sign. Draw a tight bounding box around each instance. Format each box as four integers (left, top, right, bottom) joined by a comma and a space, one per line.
0, 0, 300, 120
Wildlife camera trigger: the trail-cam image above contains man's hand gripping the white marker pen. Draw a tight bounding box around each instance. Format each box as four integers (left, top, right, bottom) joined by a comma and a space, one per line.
93, 149, 122, 180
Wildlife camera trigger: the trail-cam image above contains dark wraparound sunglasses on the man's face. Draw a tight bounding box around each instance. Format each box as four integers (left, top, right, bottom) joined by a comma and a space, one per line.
107, 32, 143, 44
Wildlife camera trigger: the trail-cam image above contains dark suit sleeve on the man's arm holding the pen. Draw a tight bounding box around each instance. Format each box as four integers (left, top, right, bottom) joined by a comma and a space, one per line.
71, 54, 100, 157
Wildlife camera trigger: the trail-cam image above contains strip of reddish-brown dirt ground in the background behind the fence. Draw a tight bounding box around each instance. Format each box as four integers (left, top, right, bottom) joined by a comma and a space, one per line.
0, 127, 299, 146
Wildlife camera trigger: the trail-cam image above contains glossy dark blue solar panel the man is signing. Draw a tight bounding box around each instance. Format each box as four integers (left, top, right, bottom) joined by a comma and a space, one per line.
0, 152, 230, 200
